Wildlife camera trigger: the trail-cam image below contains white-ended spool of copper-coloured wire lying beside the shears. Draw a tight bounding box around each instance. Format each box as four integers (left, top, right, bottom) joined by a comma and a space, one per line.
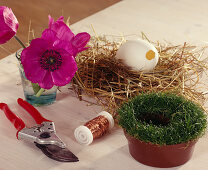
74, 111, 114, 145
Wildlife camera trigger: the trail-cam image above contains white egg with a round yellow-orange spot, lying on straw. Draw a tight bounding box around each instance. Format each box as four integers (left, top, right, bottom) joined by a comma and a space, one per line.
116, 40, 159, 72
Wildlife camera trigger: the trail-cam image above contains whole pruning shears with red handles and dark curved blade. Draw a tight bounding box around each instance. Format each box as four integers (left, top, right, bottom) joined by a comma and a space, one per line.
0, 98, 79, 162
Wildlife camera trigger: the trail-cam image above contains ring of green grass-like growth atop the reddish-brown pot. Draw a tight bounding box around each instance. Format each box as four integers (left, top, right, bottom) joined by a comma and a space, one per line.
118, 93, 207, 145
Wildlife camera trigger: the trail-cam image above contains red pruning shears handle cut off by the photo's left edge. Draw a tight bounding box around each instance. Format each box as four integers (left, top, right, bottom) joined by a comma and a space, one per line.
0, 103, 25, 138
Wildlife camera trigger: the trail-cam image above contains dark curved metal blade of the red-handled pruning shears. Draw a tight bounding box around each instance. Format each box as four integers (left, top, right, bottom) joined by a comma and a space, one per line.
35, 143, 79, 162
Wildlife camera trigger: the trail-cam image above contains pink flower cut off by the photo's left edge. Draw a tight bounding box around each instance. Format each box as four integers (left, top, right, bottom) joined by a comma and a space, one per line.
0, 6, 19, 44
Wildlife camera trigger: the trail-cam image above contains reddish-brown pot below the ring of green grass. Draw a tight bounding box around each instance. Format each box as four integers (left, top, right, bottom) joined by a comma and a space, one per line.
124, 131, 197, 168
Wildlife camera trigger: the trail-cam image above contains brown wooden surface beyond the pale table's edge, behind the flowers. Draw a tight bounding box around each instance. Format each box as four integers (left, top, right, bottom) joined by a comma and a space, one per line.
0, 0, 120, 59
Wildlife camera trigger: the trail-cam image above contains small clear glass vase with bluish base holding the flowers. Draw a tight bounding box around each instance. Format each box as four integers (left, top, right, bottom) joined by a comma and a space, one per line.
19, 66, 57, 106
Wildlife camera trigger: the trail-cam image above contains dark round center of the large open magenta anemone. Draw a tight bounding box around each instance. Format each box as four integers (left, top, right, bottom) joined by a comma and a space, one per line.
40, 50, 62, 71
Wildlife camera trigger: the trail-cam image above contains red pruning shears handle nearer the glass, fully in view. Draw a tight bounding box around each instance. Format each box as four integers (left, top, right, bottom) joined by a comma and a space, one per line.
17, 98, 51, 124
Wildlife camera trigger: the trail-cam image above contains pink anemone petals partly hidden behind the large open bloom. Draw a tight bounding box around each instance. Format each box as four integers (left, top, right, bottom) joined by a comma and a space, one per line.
48, 15, 90, 57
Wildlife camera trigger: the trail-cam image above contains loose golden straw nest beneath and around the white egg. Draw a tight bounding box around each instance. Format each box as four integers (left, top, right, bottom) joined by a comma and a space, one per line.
72, 36, 208, 116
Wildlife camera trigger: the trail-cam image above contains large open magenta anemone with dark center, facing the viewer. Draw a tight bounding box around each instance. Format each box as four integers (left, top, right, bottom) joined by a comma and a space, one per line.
21, 29, 77, 89
